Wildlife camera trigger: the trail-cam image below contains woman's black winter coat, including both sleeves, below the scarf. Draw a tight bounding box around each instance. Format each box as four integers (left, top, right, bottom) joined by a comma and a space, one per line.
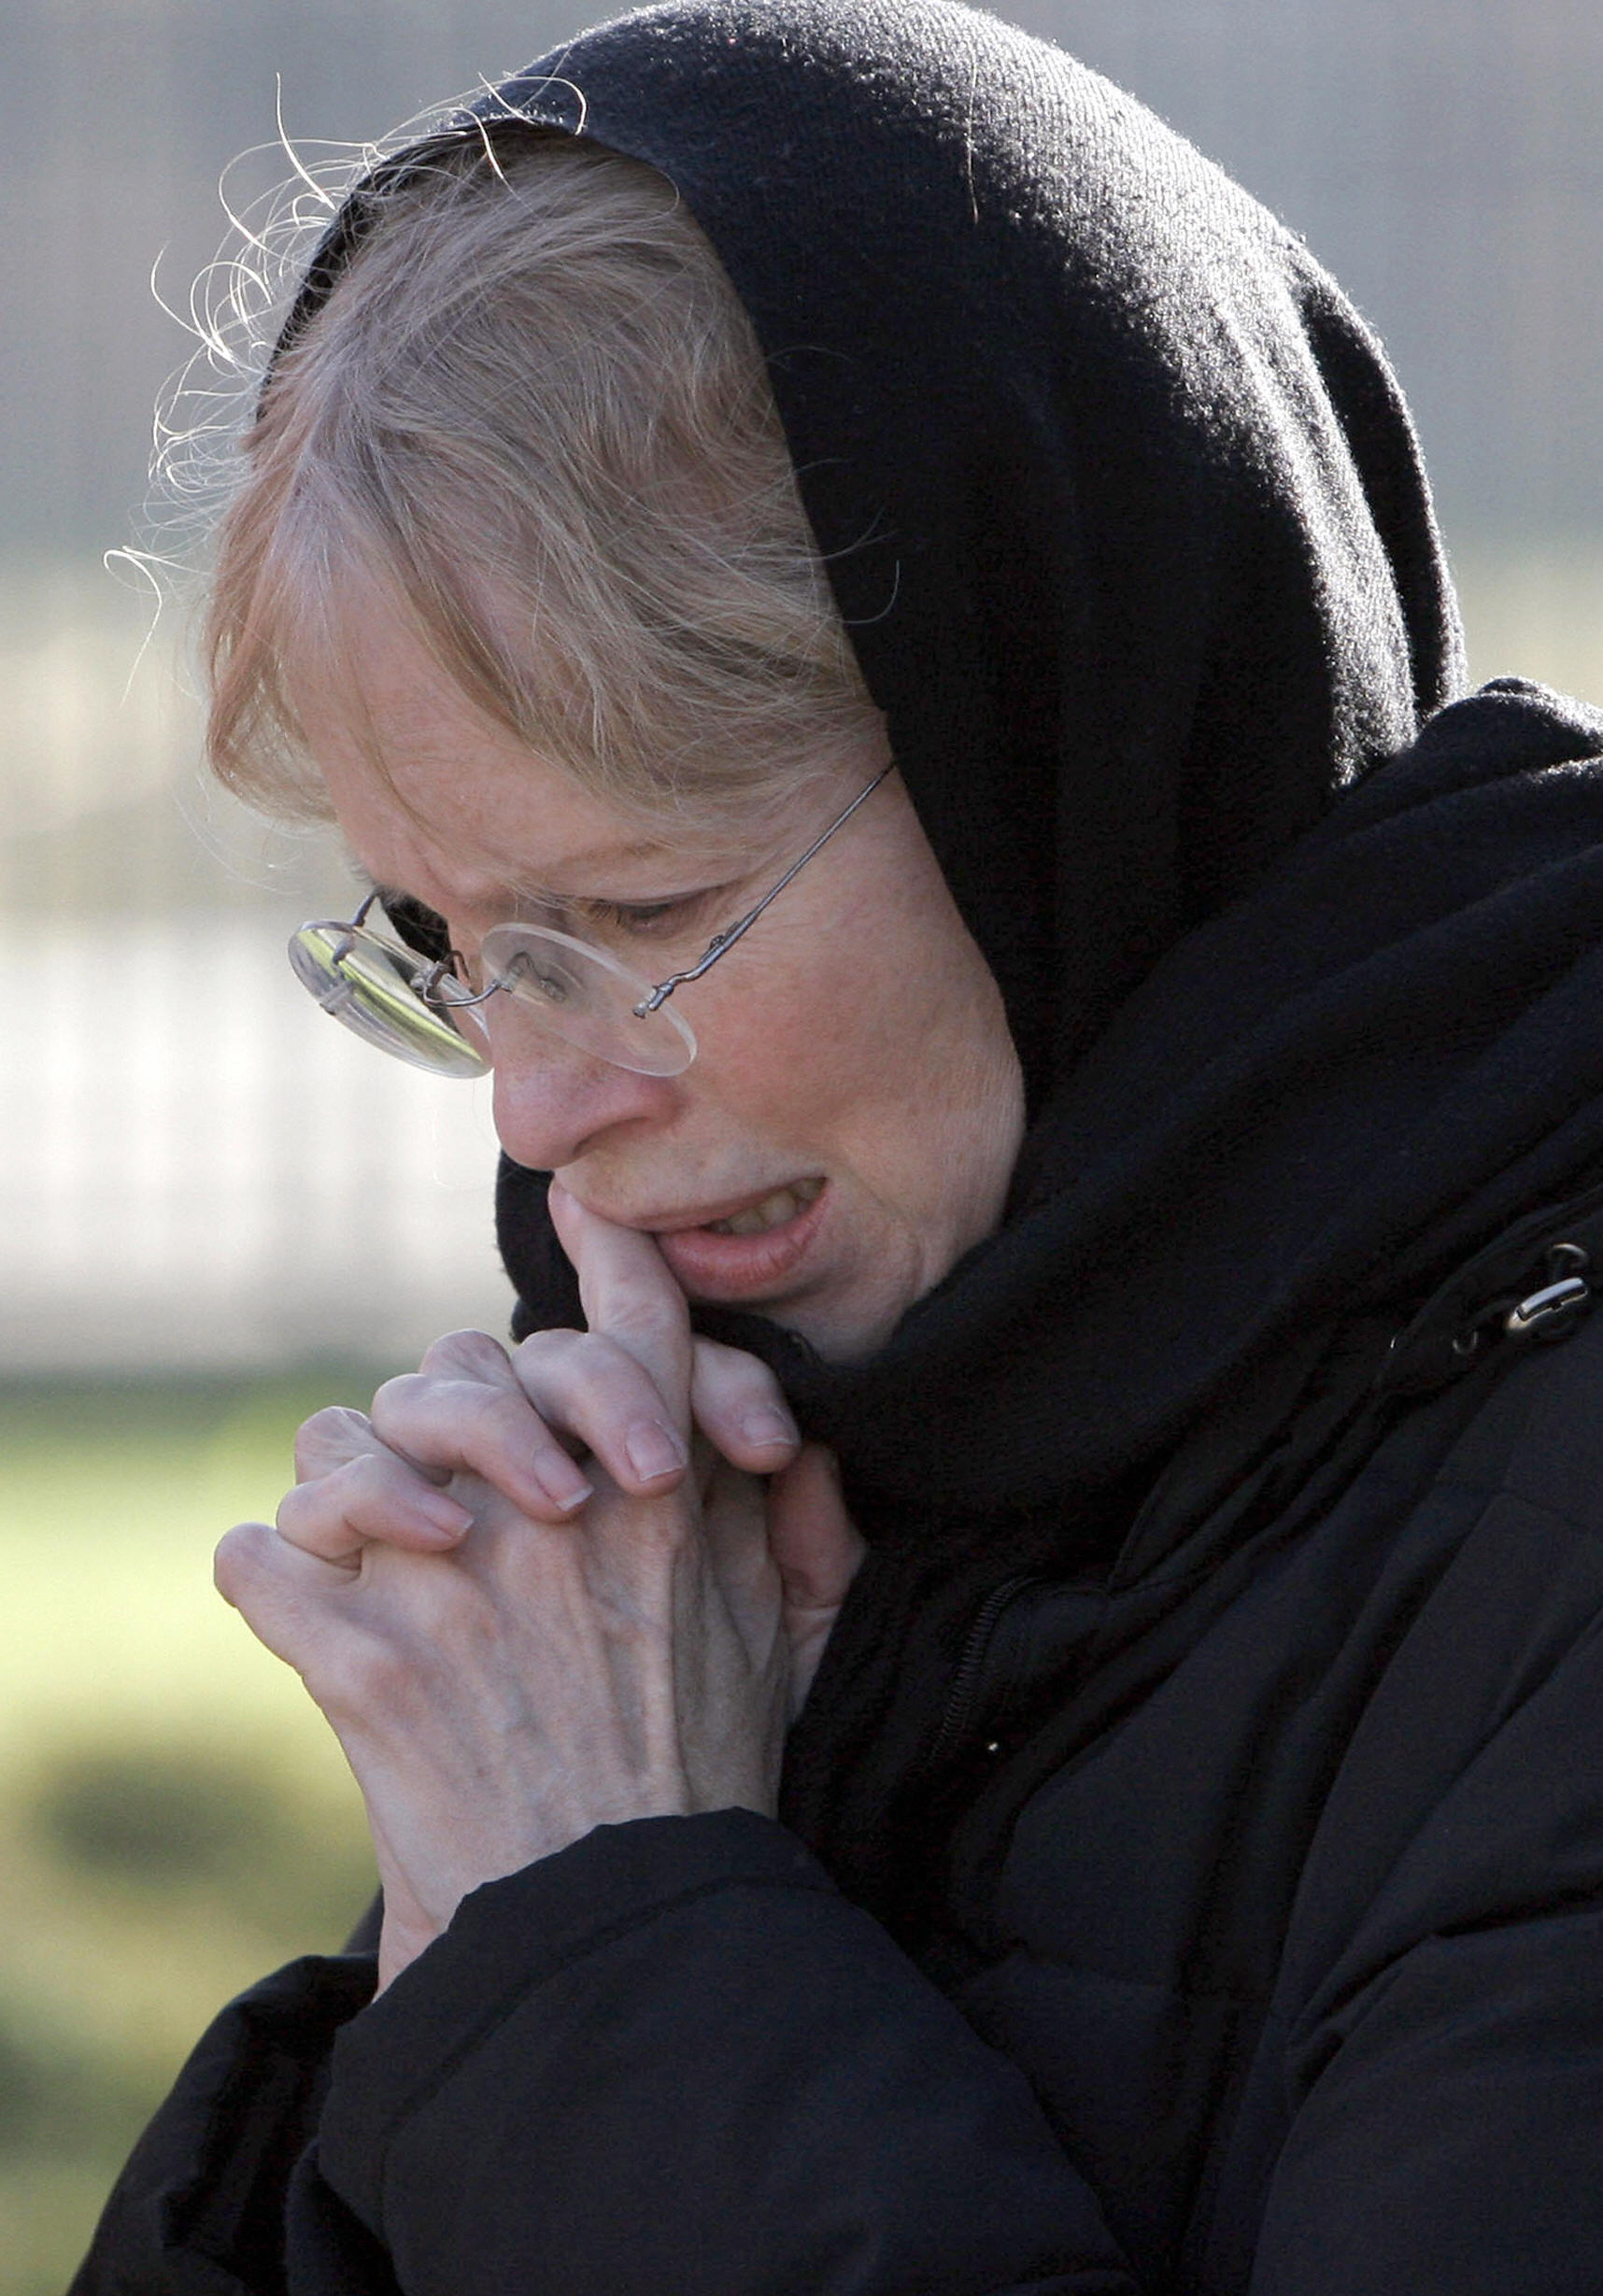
74, 1240, 1603, 2296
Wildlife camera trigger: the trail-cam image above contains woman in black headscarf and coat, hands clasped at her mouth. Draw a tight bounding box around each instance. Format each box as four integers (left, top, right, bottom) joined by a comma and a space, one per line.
78, 0, 1603, 2296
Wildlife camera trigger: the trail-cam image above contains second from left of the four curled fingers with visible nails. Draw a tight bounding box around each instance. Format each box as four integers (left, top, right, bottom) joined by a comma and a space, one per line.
372, 1370, 592, 1523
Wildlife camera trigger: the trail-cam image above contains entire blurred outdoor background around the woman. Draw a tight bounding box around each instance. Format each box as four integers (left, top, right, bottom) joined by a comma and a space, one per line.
0, 0, 1603, 2296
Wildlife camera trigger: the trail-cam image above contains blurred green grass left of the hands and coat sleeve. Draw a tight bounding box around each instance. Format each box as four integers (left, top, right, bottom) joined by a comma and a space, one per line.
0, 1375, 392, 2296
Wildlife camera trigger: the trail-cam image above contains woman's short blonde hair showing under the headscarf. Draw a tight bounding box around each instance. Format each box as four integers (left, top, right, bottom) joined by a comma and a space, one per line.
202, 126, 877, 820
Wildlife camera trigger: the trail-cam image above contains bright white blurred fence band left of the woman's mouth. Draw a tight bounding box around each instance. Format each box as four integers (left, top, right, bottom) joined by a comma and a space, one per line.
0, 912, 507, 1375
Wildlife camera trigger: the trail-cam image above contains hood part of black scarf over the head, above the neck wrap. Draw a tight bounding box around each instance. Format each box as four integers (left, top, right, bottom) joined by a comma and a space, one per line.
482, 0, 1461, 1102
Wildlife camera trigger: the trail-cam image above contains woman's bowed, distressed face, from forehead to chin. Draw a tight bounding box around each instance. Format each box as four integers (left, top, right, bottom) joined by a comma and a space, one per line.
296, 611, 1024, 1359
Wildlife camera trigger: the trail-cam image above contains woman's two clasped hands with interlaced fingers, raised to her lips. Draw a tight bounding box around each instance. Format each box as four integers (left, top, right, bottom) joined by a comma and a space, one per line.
216, 1183, 863, 1986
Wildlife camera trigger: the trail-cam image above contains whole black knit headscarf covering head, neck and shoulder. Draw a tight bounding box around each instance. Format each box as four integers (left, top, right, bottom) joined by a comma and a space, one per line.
291, 0, 1603, 1901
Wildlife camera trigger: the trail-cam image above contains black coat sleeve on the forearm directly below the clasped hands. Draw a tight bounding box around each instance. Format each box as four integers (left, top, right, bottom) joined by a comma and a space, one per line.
314, 1809, 1134, 2296
